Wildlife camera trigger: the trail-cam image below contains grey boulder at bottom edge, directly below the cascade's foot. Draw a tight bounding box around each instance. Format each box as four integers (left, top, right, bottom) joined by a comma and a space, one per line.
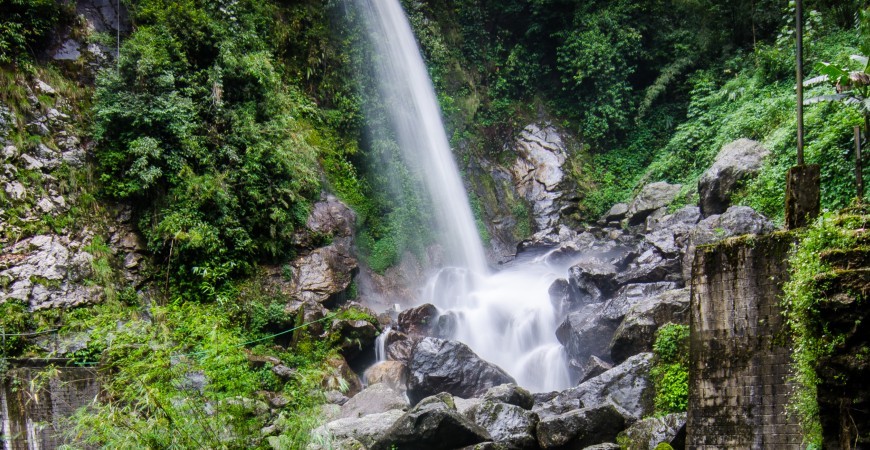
465, 400, 538, 450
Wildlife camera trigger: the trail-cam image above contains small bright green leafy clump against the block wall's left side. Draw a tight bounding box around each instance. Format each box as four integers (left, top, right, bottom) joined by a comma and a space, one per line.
650, 323, 689, 415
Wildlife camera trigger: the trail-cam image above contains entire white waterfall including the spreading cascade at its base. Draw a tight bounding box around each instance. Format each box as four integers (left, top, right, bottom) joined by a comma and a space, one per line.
356, 0, 570, 391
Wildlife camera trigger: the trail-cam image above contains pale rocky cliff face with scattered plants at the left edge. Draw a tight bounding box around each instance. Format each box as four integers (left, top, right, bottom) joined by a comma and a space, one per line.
0, 77, 147, 310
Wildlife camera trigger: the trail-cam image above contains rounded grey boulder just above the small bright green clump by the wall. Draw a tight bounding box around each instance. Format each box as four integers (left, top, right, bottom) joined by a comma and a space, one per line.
610, 289, 689, 363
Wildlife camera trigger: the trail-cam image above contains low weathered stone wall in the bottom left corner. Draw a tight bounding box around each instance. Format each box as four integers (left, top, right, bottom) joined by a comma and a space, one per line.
0, 367, 100, 450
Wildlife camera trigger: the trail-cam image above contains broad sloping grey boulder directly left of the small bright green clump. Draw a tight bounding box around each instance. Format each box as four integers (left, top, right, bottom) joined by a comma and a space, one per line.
535, 353, 653, 422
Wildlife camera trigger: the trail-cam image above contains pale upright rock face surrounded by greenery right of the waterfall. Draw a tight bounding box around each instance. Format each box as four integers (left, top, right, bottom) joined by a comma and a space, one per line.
511, 124, 580, 230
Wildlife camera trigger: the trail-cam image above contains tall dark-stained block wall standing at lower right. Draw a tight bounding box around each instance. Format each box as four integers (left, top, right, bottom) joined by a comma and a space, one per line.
686, 233, 802, 450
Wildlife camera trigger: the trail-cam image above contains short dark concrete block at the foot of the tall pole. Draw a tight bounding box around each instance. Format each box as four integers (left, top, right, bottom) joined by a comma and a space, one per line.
785, 164, 821, 230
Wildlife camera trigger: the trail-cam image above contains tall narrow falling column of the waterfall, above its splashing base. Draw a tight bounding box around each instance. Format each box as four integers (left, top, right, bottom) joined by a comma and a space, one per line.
357, 0, 487, 273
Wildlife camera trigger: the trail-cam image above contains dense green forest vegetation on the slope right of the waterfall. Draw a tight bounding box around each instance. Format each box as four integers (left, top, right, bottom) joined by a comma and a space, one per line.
405, 0, 866, 221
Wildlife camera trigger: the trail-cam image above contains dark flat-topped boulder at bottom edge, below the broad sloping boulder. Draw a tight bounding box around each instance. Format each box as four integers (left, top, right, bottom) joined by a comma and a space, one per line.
537, 405, 625, 449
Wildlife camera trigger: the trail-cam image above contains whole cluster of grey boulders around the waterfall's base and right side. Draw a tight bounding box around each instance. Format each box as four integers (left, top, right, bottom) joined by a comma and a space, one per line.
311, 136, 774, 449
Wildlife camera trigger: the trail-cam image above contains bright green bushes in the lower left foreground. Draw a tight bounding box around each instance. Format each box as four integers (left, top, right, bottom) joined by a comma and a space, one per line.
56, 302, 342, 448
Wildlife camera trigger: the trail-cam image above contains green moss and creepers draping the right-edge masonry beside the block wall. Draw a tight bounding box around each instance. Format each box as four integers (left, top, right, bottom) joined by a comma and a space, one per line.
782, 211, 867, 448
